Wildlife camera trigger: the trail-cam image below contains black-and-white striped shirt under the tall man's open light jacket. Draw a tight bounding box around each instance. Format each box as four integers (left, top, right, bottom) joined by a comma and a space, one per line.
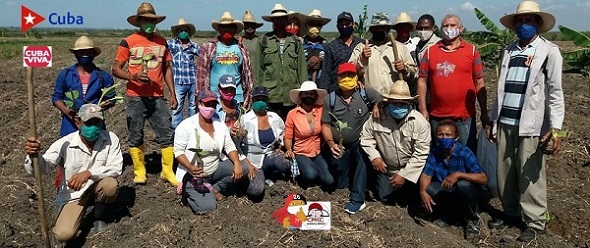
498, 39, 539, 126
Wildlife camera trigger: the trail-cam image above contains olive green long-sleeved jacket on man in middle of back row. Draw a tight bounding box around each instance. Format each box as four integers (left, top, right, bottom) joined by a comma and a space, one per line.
252, 32, 307, 106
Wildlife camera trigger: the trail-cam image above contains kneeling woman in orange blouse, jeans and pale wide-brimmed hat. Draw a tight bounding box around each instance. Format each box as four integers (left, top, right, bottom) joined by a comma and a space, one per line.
285, 81, 334, 185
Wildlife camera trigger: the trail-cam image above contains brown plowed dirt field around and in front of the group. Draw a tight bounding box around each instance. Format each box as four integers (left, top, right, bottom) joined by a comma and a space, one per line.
0, 38, 590, 247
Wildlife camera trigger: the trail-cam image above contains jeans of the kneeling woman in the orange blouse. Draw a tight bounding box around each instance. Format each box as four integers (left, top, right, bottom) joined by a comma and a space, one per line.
295, 154, 334, 186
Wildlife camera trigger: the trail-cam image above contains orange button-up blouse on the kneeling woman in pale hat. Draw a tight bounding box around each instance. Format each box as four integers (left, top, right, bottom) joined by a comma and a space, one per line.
285, 105, 323, 157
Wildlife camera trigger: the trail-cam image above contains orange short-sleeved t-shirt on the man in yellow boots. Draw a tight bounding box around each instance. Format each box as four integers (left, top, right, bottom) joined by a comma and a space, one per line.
115, 33, 172, 96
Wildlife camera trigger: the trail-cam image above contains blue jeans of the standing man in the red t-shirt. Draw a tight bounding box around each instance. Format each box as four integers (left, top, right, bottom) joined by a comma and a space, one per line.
430, 116, 477, 155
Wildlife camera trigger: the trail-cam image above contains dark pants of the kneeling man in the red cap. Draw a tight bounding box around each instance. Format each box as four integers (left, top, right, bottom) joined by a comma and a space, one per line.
324, 141, 370, 202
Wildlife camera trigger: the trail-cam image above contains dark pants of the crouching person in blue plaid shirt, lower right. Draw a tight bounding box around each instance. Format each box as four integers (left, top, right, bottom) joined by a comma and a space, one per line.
426, 180, 479, 220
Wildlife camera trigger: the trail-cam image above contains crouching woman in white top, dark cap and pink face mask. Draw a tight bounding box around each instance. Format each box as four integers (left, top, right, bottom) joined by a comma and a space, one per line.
174, 90, 248, 214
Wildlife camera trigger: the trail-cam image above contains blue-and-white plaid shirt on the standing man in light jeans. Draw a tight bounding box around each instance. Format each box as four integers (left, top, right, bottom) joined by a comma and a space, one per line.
168, 38, 201, 85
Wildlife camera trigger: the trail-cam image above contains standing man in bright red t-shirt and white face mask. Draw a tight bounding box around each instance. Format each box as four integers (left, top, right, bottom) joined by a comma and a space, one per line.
418, 14, 489, 153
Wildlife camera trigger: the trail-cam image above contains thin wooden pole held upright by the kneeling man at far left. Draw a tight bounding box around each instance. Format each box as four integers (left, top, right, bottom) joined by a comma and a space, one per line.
27, 67, 51, 248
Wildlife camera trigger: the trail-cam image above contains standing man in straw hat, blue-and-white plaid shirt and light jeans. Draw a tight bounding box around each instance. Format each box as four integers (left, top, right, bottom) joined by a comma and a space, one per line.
168, 18, 201, 129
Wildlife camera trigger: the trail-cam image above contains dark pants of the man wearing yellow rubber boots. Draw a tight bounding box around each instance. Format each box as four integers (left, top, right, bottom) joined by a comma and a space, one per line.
126, 96, 174, 147
